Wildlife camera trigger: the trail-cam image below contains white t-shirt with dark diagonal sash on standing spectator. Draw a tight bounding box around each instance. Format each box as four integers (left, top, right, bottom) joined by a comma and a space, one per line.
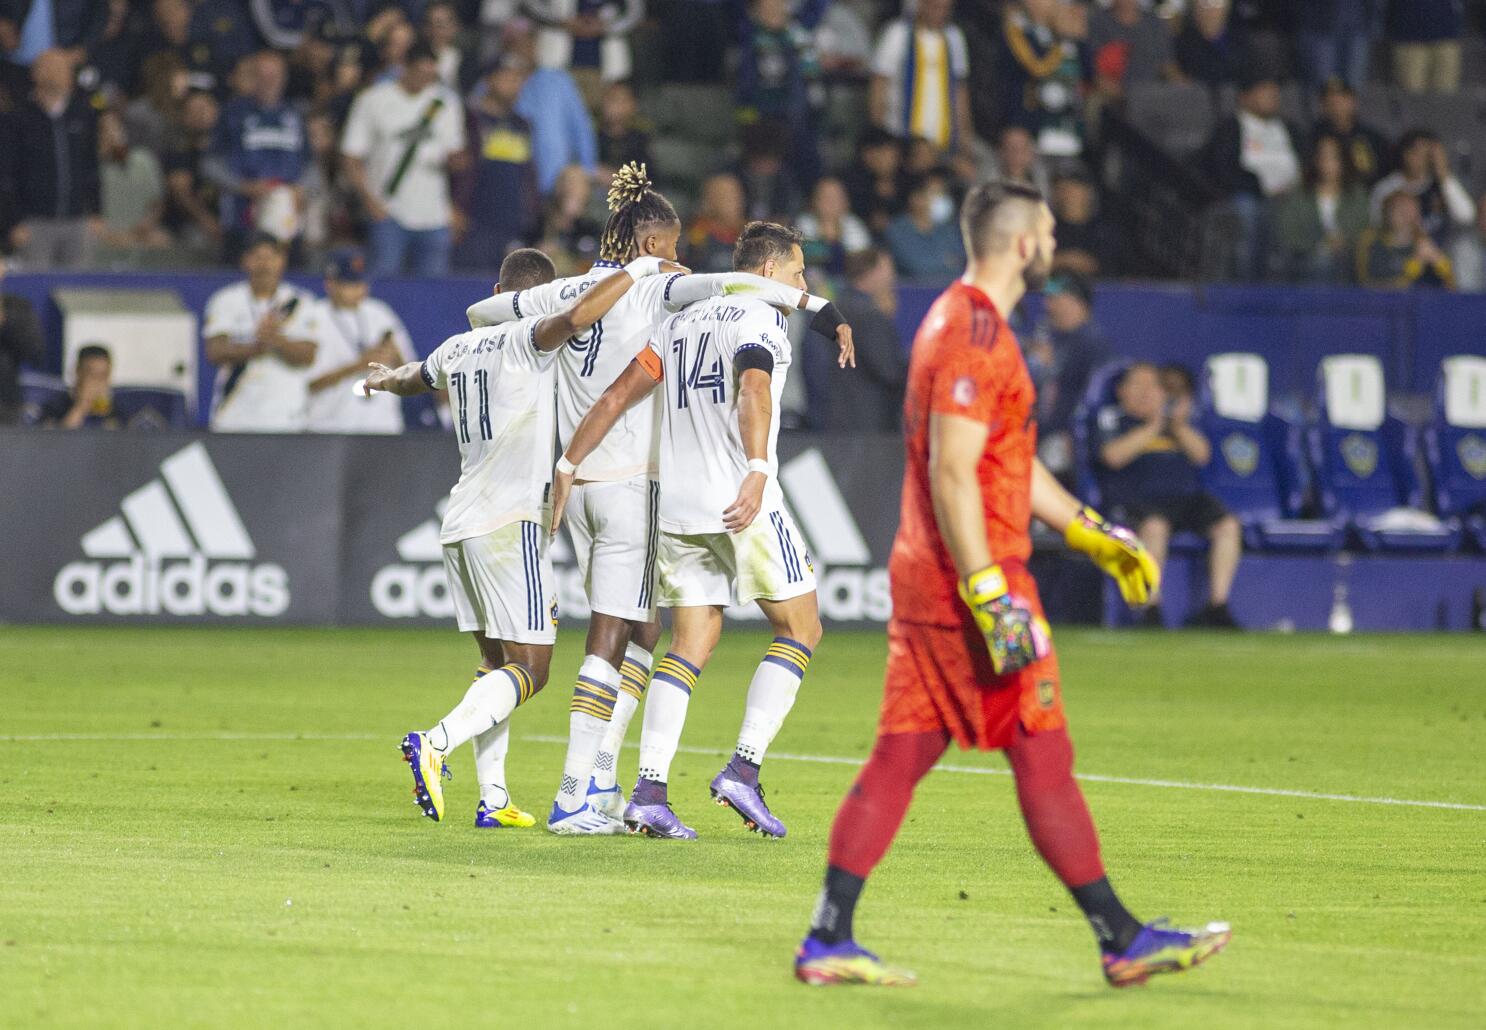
340, 82, 465, 230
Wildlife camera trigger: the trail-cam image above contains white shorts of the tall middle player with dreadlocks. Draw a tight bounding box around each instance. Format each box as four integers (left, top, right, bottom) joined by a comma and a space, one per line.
565, 476, 660, 623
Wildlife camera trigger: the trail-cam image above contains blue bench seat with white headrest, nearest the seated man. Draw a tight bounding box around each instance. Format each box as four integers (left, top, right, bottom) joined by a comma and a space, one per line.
1199, 354, 1343, 551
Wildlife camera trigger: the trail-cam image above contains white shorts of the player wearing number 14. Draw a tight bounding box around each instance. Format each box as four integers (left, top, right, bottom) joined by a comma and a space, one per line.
658, 508, 816, 608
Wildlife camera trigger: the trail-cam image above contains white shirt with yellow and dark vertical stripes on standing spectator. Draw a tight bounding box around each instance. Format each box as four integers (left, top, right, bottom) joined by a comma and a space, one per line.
872, 18, 970, 147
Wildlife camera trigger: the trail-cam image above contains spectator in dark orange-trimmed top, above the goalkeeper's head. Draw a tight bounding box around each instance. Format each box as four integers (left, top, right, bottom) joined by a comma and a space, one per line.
994, 0, 1089, 158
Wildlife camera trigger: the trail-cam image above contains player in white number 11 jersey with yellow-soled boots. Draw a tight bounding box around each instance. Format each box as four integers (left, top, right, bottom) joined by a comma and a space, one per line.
366, 250, 678, 832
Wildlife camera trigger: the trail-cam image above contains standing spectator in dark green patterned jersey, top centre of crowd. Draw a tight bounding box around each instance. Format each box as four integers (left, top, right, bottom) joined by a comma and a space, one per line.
737, 0, 820, 186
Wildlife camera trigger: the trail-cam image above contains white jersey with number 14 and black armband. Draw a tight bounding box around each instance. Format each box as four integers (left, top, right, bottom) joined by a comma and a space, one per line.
649, 297, 791, 535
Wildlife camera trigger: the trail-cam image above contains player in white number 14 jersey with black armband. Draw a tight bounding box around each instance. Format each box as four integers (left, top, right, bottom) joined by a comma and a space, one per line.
553, 221, 850, 840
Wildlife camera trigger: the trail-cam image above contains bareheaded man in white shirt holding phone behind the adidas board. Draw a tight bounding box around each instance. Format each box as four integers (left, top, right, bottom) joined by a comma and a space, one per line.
201, 233, 319, 433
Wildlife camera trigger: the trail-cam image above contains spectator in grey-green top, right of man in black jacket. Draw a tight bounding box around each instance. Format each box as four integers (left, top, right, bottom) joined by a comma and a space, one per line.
1275, 135, 1369, 282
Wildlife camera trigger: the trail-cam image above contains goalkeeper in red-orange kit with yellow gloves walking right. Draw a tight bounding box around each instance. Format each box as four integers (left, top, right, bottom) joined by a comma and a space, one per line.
795, 183, 1229, 987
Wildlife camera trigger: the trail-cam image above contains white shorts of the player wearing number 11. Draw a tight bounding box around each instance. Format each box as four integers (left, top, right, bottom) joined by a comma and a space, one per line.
444, 522, 557, 644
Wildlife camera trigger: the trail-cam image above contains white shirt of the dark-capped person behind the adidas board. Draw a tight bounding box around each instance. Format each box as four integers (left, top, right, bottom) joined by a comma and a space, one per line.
305, 297, 413, 433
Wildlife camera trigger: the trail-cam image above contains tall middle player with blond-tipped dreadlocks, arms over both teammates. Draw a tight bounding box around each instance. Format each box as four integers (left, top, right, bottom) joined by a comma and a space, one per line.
467, 163, 850, 834
